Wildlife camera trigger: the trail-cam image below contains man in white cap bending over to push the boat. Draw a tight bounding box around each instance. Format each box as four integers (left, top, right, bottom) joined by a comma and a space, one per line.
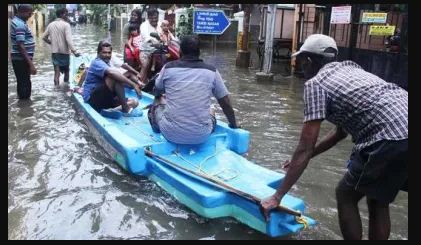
261, 34, 409, 239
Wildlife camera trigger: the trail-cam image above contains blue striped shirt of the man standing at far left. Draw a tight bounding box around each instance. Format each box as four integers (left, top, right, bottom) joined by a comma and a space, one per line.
10, 16, 35, 60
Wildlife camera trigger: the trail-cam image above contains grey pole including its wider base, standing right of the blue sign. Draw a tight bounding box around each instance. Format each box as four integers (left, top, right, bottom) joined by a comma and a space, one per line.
256, 4, 276, 81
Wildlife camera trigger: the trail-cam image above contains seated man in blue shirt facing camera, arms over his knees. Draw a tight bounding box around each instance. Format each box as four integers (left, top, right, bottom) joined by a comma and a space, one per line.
83, 40, 141, 113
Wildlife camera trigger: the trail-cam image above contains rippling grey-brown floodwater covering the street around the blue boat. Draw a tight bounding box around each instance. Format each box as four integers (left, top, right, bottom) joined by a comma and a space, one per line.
8, 25, 408, 240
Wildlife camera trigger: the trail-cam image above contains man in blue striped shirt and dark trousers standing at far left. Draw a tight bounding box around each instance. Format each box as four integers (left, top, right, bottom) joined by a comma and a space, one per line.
10, 4, 37, 99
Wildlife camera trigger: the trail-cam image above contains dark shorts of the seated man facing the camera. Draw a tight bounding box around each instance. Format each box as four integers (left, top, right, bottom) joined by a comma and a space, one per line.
88, 84, 120, 112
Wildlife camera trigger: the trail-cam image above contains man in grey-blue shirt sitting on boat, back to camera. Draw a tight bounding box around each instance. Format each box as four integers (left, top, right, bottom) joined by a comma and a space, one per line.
148, 36, 238, 144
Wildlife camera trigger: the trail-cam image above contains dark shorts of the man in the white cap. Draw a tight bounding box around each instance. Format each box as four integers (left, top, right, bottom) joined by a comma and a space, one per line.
338, 139, 409, 203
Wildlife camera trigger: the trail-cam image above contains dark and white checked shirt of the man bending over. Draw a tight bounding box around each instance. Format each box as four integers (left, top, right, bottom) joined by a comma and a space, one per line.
304, 61, 408, 151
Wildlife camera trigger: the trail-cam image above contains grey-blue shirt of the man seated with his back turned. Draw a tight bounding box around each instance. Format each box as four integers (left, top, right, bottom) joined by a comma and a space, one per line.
155, 57, 228, 144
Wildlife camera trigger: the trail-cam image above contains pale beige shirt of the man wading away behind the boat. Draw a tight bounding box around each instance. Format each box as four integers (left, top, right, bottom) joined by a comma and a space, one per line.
42, 18, 75, 54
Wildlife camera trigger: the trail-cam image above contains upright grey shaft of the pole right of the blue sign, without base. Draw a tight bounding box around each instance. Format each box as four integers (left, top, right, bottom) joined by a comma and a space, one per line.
263, 4, 276, 73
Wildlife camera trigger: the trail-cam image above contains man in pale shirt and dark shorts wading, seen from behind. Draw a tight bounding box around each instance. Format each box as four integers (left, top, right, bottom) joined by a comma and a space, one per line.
42, 8, 80, 85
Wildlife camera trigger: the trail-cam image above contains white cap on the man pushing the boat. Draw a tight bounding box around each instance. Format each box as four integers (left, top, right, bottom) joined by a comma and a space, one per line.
291, 34, 338, 57
